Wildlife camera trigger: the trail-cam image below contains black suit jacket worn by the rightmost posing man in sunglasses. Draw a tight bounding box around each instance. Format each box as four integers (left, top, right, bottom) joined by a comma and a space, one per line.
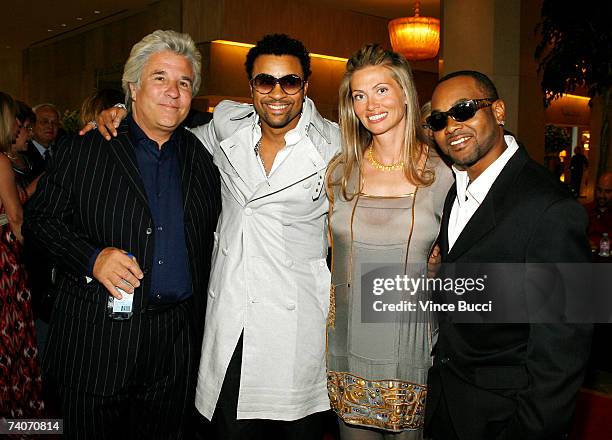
425, 149, 592, 440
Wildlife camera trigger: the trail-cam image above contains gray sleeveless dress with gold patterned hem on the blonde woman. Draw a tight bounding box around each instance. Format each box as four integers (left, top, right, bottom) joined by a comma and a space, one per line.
327, 156, 453, 439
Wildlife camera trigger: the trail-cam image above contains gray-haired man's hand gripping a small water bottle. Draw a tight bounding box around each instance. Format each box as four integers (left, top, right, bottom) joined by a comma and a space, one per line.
93, 247, 144, 299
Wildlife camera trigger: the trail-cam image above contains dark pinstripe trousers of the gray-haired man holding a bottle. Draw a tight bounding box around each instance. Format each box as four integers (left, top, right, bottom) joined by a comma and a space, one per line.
58, 300, 195, 440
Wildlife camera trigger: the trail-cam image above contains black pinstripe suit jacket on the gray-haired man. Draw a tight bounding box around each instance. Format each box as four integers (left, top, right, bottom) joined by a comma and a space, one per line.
23, 122, 221, 395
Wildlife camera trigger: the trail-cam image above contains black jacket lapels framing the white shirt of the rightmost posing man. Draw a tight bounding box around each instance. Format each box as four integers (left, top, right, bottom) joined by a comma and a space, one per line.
443, 148, 528, 261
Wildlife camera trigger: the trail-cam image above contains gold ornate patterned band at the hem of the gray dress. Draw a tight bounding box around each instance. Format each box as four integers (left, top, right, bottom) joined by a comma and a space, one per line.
327, 371, 427, 431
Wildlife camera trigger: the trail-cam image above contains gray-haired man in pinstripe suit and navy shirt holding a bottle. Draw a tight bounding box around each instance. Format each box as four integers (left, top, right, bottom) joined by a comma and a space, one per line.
24, 31, 221, 439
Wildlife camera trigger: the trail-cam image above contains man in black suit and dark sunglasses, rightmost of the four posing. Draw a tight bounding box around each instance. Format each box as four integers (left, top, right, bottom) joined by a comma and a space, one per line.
425, 71, 591, 440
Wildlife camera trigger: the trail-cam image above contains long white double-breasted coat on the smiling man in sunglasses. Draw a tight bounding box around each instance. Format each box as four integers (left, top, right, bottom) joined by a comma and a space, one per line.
193, 98, 340, 420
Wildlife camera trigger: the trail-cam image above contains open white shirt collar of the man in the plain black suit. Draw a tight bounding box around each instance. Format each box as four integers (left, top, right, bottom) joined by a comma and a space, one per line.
453, 135, 519, 206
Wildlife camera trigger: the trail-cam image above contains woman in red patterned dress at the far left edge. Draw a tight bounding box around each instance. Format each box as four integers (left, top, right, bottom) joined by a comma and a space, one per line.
0, 92, 44, 418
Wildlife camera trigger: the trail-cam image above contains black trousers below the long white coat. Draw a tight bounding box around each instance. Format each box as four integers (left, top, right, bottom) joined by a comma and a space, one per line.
212, 336, 325, 440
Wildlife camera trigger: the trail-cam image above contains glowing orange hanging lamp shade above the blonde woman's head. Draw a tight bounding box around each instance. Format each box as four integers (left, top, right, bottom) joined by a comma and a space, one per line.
389, 15, 440, 60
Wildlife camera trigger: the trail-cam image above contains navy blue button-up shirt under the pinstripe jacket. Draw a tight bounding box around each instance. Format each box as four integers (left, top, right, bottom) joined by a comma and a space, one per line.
128, 115, 192, 305
